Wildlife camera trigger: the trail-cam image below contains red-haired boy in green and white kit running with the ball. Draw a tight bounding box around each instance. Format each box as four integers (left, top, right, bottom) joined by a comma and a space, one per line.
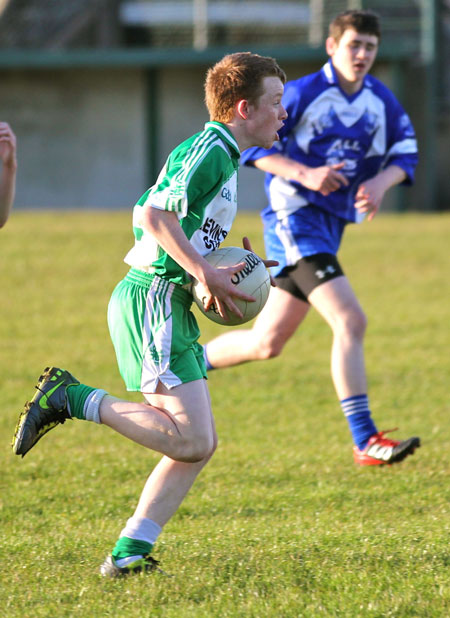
13, 52, 286, 577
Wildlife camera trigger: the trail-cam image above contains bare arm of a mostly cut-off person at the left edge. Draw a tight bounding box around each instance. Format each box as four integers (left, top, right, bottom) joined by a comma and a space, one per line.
0, 122, 17, 227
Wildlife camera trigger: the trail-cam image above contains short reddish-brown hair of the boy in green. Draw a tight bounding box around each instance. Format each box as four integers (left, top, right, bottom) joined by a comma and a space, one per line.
205, 52, 286, 122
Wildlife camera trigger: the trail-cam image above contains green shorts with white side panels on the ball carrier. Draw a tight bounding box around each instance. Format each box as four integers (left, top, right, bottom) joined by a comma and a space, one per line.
108, 268, 206, 393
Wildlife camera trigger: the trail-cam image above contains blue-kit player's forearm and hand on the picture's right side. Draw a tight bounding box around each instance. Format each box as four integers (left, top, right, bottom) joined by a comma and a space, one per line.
355, 165, 407, 221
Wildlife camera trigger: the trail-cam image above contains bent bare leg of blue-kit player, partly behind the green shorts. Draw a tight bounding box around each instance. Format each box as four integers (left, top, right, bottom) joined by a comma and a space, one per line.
207, 288, 309, 368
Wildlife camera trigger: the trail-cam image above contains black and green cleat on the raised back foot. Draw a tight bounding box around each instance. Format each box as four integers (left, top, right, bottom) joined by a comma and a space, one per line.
12, 367, 79, 457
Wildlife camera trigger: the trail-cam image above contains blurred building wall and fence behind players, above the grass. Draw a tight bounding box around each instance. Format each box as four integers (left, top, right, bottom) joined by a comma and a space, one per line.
0, 0, 450, 211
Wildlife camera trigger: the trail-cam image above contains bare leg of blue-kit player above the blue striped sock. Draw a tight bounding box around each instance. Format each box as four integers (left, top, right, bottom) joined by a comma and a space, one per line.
308, 277, 367, 399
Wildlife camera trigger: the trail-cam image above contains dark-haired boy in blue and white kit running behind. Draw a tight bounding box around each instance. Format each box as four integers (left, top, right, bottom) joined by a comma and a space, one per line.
205, 11, 420, 465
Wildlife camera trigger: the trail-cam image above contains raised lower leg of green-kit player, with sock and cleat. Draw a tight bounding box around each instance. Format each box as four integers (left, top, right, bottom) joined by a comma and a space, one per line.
12, 367, 213, 462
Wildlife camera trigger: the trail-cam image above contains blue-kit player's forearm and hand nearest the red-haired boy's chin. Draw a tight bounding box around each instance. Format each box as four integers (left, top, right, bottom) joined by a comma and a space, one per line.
253, 154, 349, 195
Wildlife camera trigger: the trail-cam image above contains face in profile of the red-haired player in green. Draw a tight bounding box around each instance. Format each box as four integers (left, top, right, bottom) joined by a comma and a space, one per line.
247, 77, 287, 148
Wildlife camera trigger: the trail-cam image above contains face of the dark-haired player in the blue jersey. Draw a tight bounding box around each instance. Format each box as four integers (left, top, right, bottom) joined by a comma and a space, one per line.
326, 29, 378, 93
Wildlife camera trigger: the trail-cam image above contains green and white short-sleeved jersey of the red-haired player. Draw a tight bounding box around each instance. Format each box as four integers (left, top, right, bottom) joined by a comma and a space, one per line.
125, 122, 240, 285
